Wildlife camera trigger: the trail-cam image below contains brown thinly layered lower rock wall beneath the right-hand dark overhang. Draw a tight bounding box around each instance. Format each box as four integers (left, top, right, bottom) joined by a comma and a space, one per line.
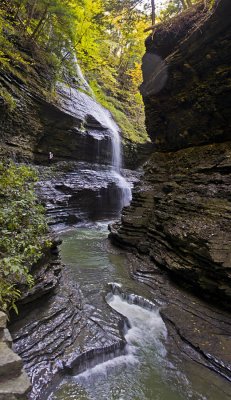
110, 142, 231, 308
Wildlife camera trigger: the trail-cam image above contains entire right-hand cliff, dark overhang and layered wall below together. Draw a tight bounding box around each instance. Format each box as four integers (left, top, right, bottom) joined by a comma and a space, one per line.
111, 0, 231, 308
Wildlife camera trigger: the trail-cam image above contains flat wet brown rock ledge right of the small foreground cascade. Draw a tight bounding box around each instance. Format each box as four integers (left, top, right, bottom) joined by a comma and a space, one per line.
124, 250, 231, 384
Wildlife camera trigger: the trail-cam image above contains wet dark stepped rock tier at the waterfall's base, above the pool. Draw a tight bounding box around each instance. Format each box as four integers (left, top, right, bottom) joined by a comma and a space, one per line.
37, 162, 137, 225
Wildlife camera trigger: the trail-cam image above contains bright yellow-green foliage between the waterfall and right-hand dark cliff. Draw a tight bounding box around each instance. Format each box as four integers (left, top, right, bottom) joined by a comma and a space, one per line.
75, 0, 150, 142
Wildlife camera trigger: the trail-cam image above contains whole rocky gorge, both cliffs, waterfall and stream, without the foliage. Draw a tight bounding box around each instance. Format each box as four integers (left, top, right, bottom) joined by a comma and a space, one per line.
0, 0, 231, 400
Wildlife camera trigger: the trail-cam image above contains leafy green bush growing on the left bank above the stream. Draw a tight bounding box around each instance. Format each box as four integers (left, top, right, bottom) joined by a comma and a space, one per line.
0, 162, 49, 311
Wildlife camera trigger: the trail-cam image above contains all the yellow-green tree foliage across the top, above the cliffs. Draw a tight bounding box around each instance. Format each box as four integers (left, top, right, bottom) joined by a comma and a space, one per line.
0, 0, 211, 141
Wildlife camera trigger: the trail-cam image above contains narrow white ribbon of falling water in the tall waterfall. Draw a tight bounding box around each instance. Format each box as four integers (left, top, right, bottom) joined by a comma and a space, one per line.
57, 57, 132, 211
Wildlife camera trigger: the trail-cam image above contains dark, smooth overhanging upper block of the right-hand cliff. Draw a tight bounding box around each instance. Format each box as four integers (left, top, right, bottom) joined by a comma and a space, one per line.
141, 0, 231, 151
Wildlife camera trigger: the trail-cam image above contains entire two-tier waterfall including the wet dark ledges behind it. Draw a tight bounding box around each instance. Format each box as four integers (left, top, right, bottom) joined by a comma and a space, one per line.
51, 65, 136, 223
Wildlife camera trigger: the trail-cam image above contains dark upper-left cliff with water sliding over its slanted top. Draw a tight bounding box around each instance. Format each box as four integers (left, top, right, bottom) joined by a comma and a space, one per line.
0, 70, 111, 164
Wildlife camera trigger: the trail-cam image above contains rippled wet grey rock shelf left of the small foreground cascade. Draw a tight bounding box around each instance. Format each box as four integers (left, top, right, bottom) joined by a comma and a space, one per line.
11, 270, 125, 400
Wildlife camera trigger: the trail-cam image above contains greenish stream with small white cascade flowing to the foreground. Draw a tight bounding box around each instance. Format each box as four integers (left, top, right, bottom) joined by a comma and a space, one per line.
49, 222, 228, 400
